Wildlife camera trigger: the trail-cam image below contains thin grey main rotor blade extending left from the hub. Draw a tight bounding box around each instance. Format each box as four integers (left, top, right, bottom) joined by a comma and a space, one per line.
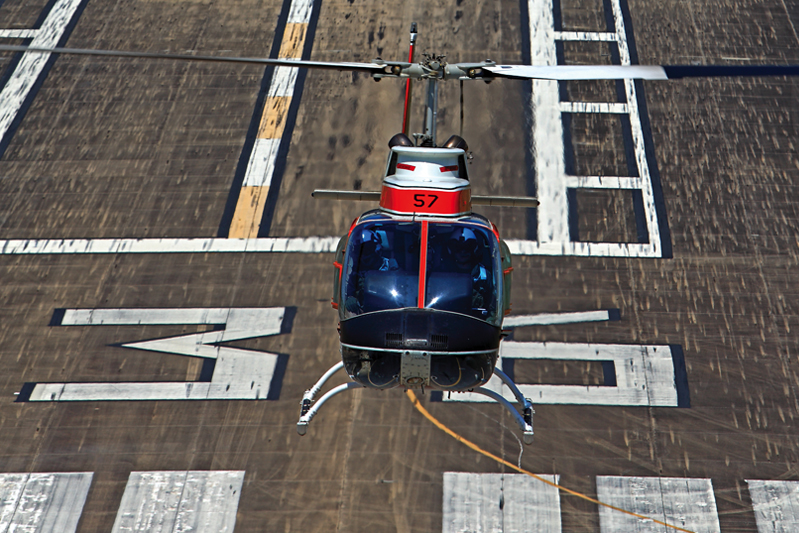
0, 44, 386, 73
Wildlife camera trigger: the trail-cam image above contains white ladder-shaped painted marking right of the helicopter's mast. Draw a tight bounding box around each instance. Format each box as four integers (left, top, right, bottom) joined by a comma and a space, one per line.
528, 0, 662, 258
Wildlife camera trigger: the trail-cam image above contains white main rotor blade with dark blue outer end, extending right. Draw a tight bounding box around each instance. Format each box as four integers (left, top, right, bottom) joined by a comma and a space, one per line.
483, 65, 799, 81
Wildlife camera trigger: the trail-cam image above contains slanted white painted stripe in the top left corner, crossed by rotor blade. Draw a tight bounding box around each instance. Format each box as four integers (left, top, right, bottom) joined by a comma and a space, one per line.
0, 0, 82, 143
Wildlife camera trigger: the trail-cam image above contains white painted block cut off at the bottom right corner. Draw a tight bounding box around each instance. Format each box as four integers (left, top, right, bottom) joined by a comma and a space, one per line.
746, 479, 799, 533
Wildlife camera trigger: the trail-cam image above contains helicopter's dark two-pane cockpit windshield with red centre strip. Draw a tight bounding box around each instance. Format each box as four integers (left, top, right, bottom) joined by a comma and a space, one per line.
342, 219, 501, 325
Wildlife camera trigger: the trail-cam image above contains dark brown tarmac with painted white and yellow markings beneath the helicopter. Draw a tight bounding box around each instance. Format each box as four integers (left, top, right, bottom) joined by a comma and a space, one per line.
0, 0, 799, 533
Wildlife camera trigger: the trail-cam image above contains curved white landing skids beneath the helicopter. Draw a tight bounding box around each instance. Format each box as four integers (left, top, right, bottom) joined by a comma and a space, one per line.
297, 362, 535, 444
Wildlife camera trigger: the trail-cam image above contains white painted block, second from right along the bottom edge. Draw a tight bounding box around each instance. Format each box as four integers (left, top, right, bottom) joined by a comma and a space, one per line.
596, 476, 720, 533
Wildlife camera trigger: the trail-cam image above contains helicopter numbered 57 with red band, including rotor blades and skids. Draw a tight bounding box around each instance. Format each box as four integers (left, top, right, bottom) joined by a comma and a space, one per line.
0, 24, 799, 444
